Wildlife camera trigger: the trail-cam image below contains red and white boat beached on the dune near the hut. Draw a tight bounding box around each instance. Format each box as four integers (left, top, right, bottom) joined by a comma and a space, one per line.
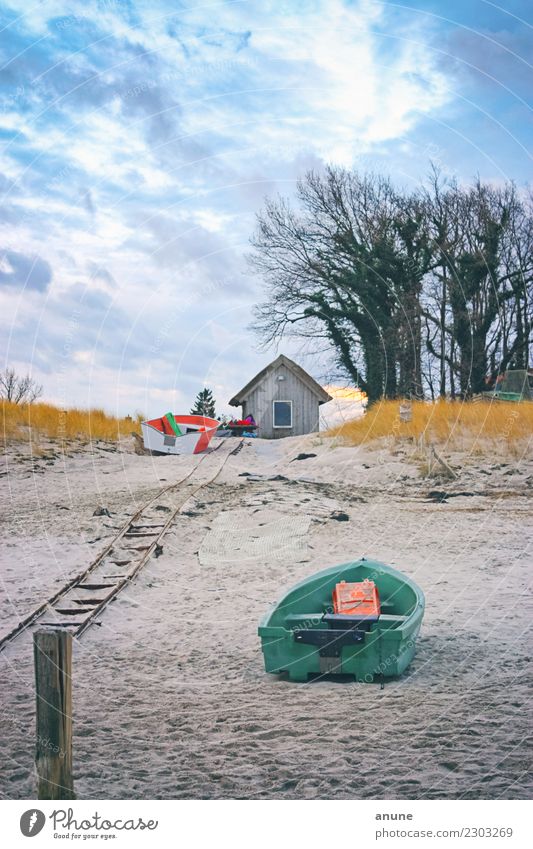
141, 413, 220, 454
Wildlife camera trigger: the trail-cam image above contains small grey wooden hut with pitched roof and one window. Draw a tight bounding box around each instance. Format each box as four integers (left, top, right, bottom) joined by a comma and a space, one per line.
229, 354, 331, 439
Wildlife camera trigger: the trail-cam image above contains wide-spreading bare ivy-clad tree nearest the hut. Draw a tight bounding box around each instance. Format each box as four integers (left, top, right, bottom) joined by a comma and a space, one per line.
250, 168, 431, 400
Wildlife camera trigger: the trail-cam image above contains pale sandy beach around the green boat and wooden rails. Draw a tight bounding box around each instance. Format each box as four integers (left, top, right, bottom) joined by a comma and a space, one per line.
0, 435, 533, 799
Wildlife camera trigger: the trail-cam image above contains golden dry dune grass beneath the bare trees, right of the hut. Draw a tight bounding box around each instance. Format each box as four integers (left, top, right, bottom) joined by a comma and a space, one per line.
330, 400, 533, 454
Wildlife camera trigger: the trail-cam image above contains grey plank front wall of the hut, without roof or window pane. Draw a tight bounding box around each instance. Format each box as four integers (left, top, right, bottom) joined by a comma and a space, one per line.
242, 365, 319, 439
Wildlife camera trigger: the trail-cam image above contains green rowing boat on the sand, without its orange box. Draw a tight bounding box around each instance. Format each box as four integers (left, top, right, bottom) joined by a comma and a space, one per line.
259, 559, 425, 683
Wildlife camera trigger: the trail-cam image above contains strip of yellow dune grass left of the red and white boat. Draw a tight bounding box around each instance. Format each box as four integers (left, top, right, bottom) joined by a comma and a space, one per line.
1, 401, 141, 442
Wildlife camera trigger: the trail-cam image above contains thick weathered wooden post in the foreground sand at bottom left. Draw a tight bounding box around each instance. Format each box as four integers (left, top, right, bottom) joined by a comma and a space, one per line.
33, 629, 75, 799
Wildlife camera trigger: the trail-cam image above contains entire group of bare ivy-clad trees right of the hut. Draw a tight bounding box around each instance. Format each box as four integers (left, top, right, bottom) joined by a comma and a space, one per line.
249, 168, 533, 401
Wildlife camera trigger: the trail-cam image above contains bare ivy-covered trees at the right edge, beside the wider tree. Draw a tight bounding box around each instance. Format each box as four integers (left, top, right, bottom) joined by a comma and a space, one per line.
423, 172, 533, 397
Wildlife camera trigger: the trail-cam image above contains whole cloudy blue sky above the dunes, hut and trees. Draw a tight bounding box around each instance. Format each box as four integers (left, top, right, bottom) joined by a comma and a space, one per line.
0, 0, 533, 417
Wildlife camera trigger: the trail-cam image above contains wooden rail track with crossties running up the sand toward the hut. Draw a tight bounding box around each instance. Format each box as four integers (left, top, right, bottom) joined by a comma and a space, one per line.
0, 439, 242, 651
